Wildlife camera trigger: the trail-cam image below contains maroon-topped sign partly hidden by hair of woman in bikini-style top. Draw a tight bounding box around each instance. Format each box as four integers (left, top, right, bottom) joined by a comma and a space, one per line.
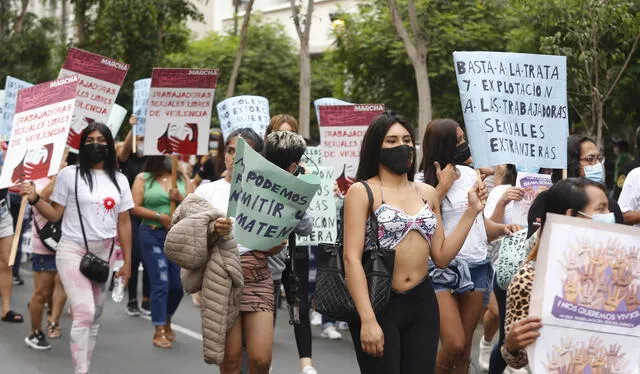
319, 104, 384, 194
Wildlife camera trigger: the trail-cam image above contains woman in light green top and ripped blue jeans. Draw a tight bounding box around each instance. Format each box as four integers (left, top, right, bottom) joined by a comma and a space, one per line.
132, 156, 193, 348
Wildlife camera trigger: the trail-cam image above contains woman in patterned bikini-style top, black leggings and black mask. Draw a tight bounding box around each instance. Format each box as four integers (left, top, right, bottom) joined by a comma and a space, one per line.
344, 113, 487, 374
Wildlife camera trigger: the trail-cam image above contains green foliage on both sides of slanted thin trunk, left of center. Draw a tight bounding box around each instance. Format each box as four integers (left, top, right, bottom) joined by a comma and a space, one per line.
165, 15, 298, 131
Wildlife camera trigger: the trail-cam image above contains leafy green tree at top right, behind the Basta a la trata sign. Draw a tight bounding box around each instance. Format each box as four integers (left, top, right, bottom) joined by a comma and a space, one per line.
504, 0, 640, 146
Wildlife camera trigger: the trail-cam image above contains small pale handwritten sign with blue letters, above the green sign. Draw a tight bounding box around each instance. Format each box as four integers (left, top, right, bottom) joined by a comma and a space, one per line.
216, 95, 271, 139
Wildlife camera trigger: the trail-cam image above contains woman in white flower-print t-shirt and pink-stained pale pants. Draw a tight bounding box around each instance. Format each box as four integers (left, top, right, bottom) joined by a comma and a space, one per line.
22, 122, 134, 373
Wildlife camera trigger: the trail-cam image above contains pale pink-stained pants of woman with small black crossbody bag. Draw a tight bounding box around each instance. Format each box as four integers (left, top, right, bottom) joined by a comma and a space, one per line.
56, 240, 111, 374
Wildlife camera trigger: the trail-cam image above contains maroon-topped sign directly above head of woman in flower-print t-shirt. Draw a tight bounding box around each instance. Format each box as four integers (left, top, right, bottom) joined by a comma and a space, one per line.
58, 48, 129, 150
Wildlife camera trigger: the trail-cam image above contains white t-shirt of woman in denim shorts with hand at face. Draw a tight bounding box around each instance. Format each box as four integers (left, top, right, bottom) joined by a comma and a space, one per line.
440, 165, 487, 263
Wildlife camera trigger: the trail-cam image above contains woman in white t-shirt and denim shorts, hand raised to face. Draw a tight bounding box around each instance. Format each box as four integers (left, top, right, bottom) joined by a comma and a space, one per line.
420, 119, 519, 374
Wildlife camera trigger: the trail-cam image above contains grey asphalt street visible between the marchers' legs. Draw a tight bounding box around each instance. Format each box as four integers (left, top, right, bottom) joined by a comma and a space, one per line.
0, 266, 479, 374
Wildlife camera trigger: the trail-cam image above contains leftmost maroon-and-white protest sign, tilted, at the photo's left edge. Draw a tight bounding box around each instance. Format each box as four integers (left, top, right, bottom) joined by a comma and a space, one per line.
0, 75, 79, 188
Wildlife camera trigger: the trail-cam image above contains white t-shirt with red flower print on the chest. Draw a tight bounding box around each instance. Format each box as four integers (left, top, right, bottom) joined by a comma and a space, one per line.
51, 166, 134, 243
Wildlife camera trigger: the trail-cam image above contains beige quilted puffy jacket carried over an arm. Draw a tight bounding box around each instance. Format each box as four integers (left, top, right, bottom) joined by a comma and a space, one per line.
164, 194, 243, 365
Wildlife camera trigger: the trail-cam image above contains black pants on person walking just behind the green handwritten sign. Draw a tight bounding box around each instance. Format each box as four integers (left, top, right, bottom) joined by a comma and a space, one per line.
282, 247, 311, 358
